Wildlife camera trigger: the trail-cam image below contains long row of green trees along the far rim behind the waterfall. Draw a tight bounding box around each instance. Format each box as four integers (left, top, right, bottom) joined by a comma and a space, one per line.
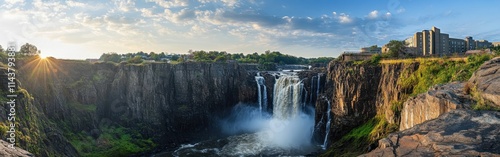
99, 50, 334, 65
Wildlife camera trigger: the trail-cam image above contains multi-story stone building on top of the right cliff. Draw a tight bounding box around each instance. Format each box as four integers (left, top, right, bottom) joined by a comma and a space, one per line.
405, 27, 492, 55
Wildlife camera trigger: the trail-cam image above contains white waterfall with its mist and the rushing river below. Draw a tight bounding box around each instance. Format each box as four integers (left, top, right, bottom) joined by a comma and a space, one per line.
173, 74, 320, 156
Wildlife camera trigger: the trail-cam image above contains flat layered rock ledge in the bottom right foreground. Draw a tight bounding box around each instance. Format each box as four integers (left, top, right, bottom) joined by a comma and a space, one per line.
361, 110, 500, 156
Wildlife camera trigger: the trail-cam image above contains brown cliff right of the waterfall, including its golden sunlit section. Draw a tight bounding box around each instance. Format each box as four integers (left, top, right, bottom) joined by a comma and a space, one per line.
316, 62, 418, 145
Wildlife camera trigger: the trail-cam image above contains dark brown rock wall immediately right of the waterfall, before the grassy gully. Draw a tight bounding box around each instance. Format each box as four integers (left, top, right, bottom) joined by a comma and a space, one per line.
315, 62, 381, 144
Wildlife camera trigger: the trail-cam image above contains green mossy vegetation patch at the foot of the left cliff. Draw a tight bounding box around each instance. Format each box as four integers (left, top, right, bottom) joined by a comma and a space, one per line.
65, 126, 156, 157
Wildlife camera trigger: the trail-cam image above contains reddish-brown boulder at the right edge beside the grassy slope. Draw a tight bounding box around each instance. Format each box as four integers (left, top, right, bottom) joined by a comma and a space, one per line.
469, 57, 500, 107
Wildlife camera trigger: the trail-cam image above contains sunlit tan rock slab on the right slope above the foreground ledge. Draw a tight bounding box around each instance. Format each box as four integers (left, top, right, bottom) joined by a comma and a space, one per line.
399, 82, 473, 130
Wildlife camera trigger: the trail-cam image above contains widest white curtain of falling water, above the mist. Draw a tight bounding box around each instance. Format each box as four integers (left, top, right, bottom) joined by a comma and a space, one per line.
273, 75, 303, 119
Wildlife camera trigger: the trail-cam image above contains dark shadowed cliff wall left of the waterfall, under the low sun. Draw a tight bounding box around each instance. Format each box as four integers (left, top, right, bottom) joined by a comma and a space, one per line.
12, 59, 257, 156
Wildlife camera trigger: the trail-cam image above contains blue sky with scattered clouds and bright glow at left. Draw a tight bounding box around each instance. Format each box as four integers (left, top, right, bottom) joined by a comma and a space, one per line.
0, 0, 500, 59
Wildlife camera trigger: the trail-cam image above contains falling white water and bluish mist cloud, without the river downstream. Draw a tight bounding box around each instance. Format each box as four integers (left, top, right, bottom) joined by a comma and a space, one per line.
220, 75, 314, 155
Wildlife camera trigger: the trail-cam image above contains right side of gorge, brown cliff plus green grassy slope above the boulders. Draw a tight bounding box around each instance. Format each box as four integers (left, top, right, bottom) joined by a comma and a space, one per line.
315, 55, 495, 156
